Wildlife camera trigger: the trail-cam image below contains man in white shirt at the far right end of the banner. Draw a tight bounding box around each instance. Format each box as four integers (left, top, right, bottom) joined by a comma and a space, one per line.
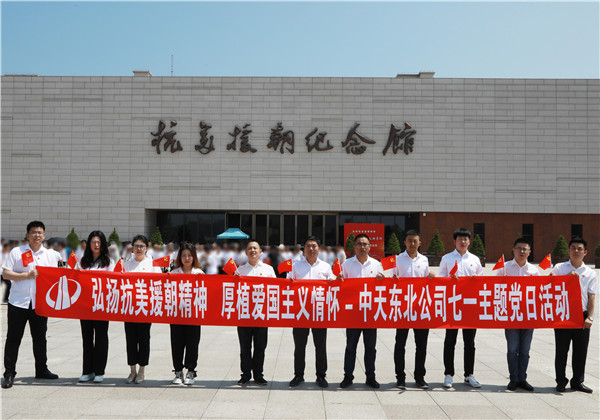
552, 237, 598, 394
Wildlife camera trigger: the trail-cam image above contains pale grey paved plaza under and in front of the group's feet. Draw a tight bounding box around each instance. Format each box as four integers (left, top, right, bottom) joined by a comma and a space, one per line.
0, 264, 600, 419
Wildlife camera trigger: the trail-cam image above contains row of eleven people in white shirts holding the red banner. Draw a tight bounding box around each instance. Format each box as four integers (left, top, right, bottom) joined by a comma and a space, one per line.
2, 221, 598, 393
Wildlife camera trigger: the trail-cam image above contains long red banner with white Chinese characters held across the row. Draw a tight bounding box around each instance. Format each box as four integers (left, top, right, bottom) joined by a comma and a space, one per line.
36, 267, 583, 328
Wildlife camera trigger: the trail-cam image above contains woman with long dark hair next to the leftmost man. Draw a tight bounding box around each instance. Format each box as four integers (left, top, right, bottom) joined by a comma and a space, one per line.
79, 230, 115, 383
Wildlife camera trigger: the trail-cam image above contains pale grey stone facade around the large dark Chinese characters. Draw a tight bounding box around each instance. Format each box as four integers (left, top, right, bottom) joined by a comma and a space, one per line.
1, 76, 600, 243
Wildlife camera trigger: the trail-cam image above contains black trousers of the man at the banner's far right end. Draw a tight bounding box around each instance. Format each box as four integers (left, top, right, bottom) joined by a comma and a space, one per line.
554, 312, 590, 385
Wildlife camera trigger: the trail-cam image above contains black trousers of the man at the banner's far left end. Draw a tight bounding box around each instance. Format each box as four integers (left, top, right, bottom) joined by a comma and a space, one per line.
4, 303, 48, 376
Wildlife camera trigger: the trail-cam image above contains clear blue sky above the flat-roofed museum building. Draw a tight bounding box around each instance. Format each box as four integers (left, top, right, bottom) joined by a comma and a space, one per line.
1, 1, 600, 78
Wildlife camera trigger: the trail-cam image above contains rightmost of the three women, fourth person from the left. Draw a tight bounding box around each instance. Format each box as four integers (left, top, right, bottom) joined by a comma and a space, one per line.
171, 243, 204, 385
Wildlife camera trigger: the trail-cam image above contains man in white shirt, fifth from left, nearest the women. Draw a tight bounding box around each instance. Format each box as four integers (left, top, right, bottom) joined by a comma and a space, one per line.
236, 239, 277, 386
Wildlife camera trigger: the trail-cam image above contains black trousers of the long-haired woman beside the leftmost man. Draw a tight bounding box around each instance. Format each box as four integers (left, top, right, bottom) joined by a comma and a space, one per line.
80, 319, 108, 376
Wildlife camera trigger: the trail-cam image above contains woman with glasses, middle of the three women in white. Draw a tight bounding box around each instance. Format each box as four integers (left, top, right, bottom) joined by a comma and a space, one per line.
123, 235, 161, 384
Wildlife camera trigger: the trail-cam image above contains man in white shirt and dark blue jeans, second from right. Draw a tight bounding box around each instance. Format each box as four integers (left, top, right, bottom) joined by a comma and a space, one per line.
496, 238, 540, 392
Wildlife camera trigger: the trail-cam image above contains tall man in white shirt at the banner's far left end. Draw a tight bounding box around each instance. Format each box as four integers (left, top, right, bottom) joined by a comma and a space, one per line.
2, 221, 62, 388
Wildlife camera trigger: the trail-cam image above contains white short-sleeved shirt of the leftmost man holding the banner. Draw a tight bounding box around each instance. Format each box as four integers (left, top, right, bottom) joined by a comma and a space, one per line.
2, 245, 61, 309
